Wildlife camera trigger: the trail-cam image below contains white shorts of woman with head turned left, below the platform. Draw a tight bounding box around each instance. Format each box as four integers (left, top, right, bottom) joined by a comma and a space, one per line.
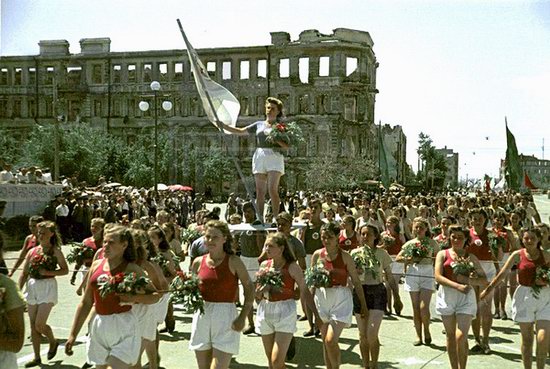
256, 299, 297, 336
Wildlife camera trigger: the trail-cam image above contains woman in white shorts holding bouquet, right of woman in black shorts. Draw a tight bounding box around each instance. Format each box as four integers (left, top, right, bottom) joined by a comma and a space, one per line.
395, 217, 439, 346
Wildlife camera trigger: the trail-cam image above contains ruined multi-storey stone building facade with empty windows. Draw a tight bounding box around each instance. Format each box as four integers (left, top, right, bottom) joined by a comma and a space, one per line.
0, 28, 378, 188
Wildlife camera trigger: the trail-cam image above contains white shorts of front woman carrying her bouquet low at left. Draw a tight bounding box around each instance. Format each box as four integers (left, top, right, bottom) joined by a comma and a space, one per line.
189, 301, 241, 355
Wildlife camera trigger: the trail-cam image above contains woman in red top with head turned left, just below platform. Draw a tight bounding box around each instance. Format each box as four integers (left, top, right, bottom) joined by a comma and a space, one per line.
256, 232, 321, 369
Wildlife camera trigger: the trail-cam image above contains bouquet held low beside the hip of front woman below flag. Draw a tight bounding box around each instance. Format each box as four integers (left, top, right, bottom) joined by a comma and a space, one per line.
170, 270, 204, 314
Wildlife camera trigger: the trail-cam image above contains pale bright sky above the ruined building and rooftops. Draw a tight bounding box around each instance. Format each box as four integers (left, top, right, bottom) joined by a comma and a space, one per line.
0, 0, 550, 178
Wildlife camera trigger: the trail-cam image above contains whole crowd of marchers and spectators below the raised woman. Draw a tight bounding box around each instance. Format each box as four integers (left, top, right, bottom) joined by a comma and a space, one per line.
0, 179, 550, 368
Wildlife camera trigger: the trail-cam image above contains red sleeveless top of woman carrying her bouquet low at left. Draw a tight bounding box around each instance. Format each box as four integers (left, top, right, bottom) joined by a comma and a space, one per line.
198, 255, 239, 302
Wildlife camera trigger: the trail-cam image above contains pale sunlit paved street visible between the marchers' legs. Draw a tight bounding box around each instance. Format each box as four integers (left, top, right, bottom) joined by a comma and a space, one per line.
5, 196, 550, 369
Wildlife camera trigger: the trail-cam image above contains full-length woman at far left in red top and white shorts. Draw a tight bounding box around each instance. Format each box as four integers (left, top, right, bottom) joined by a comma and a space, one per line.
19, 221, 69, 368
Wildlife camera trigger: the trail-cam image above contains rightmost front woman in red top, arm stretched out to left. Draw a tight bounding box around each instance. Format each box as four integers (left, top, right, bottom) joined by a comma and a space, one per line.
480, 229, 550, 369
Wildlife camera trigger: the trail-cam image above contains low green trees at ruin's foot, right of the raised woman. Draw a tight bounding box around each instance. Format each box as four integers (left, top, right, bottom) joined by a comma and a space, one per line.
305, 156, 378, 190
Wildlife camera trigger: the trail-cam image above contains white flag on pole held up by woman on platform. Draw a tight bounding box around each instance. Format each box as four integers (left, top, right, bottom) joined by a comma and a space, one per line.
178, 19, 241, 133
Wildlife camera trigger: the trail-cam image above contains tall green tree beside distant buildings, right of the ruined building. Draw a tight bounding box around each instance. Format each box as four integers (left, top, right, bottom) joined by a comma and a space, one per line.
417, 132, 447, 188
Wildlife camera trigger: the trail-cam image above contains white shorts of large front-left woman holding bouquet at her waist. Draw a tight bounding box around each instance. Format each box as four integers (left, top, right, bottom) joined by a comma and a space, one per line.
86, 310, 141, 366
